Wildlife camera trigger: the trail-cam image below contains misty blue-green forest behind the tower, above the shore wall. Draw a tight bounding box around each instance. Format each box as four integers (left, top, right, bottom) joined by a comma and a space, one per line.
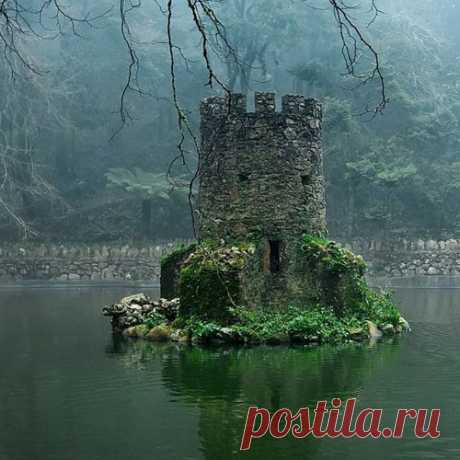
0, 0, 460, 241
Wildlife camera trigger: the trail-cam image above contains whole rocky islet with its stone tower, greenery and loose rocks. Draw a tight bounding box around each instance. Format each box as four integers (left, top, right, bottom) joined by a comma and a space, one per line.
104, 93, 409, 344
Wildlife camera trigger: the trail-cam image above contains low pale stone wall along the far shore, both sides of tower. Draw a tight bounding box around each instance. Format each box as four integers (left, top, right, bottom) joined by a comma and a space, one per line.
0, 239, 460, 282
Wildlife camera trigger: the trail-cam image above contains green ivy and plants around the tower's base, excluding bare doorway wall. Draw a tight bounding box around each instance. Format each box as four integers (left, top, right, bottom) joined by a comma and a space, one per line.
146, 235, 406, 343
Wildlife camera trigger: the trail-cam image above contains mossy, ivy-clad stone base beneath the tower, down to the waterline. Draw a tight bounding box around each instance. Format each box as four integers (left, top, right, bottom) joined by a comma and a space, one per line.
155, 235, 407, 343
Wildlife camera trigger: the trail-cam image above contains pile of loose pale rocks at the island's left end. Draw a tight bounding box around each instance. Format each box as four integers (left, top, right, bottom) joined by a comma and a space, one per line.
102, 293, 179, 332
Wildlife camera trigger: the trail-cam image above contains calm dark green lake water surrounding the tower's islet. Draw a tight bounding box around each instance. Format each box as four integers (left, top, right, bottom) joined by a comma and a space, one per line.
0, 280, 460, 460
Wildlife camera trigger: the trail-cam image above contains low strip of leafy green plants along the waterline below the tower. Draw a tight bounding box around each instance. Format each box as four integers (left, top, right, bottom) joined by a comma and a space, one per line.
179, 291, 401, 343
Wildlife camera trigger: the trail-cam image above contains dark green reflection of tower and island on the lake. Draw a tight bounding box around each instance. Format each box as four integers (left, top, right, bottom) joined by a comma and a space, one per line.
107, 337, 400, 459
